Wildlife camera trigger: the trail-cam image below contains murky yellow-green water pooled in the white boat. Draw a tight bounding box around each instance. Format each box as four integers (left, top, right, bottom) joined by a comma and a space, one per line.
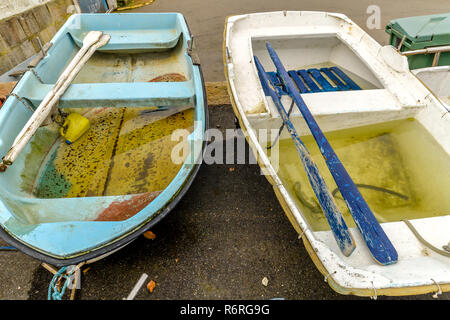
278, 120, 450, 231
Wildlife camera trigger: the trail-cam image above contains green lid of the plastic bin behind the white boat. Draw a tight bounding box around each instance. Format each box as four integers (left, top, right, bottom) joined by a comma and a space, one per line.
386, 13, 450, 45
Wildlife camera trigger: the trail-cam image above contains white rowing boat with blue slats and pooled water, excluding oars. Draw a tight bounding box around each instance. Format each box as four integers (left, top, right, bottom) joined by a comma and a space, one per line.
223, 11, 450, 296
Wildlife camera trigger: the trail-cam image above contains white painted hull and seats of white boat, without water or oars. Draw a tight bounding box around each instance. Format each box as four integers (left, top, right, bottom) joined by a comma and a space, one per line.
225, 11, 450, 292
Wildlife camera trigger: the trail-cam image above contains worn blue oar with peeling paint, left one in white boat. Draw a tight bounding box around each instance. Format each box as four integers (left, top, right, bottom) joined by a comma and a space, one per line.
255, 57, 356, 256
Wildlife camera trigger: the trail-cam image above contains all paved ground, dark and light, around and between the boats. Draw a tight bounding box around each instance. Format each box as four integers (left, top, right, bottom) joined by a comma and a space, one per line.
0, 0, 450, 300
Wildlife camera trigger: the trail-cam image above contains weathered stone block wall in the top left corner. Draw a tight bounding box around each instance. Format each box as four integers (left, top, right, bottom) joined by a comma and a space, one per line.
0, 0, 73, 75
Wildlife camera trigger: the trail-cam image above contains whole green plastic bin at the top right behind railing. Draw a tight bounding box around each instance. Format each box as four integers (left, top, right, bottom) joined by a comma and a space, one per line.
386, 13, 450, 69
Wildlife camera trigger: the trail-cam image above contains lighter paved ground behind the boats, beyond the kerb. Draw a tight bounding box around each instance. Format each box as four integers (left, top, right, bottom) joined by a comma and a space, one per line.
129, 0, 450, 81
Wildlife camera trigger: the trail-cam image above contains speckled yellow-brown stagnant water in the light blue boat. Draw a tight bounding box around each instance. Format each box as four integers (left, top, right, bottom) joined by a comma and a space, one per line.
21, 106, 194, 198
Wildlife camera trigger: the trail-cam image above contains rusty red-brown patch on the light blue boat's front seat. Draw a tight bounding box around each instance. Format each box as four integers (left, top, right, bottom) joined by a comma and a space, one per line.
95, 191, 162, 221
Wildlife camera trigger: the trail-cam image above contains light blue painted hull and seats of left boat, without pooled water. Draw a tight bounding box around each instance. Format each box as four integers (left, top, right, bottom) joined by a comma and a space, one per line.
0, 13, 208, 266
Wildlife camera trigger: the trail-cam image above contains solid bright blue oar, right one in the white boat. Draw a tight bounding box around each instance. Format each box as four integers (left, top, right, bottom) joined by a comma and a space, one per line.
266, 42, 398, 265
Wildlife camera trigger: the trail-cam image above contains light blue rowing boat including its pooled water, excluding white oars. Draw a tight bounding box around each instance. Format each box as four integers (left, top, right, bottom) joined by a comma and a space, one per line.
0, 13, 207, 266
